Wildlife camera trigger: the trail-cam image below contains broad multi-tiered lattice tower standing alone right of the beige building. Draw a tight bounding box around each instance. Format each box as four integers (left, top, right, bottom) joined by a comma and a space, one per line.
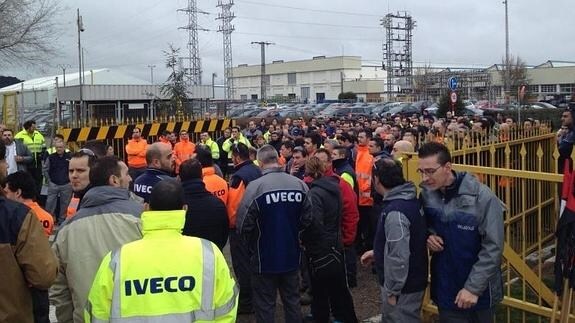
381, 11, 416, 99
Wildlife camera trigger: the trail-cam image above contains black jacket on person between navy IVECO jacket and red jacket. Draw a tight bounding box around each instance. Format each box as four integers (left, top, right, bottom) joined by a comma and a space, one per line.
302, 176, 343, 260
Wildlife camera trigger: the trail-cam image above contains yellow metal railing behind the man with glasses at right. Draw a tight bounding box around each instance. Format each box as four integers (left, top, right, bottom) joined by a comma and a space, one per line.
403, 131, 563, 322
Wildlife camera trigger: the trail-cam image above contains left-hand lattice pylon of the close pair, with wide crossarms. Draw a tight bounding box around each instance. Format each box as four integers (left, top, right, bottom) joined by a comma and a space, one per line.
178, 0, 208, 86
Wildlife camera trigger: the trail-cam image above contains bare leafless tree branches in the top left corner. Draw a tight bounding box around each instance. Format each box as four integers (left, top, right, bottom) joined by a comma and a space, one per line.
0, 0, 59, 66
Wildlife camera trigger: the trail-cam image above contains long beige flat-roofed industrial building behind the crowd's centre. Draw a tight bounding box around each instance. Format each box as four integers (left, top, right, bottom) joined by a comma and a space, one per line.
232, 56, 387, 103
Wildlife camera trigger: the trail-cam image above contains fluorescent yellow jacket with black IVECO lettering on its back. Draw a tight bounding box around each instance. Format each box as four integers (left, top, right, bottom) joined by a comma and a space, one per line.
84, 210, 238, 323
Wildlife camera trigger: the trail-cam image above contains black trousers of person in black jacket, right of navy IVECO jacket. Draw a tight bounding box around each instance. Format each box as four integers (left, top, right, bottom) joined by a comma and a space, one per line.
310, 254, 357, 323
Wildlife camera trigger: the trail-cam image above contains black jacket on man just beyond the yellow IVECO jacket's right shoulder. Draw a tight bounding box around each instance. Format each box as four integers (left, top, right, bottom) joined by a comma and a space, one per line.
182, 179, 229, 250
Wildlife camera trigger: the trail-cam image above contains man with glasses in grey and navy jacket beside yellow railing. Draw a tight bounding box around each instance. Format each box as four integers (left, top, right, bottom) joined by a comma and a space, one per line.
417, 142, 504, 323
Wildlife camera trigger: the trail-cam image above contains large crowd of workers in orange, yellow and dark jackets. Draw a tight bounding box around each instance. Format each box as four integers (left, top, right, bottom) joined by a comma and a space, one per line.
5, 107, 571, 323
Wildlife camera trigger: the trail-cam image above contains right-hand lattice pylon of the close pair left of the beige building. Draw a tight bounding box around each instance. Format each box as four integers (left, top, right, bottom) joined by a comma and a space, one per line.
216, 0, 236, 100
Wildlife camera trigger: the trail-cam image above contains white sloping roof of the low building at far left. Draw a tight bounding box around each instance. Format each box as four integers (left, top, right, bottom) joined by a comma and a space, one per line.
0, 68, 150, 93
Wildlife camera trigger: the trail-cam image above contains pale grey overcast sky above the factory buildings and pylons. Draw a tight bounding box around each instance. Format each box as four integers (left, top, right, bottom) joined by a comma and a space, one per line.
0, 0, 575, 84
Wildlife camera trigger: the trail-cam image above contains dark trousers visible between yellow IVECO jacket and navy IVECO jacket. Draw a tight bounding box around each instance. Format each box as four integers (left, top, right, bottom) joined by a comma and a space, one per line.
229, 229, 253, 313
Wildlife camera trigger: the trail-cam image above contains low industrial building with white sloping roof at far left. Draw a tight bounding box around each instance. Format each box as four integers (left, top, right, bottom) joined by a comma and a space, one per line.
0, 69, 223, 133
